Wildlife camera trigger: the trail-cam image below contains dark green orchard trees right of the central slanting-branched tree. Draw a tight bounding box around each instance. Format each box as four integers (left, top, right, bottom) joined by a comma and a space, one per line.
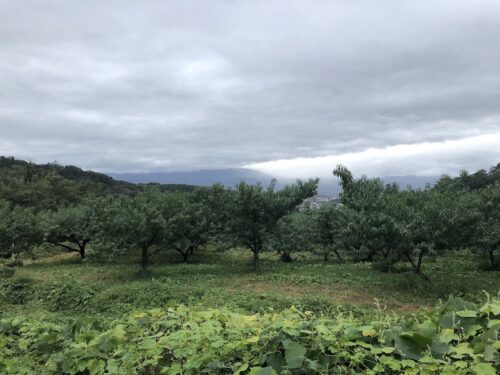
252, 165, 500, 280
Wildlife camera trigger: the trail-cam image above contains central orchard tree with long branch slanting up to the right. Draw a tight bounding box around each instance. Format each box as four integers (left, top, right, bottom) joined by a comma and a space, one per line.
230, 179, 318, 270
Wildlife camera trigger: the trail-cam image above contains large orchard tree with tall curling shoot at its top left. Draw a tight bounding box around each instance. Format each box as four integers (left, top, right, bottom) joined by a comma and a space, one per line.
334, 166, 442, 280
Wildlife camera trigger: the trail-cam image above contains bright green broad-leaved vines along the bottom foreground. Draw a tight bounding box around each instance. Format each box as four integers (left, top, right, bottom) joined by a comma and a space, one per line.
0, 298, 500, 375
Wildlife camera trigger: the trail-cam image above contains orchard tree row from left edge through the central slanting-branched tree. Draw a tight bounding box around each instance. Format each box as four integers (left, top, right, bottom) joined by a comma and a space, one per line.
0, 180, 318, 269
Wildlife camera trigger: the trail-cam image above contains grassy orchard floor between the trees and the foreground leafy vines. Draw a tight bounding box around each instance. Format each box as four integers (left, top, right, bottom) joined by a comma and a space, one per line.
1, 250, 500, 316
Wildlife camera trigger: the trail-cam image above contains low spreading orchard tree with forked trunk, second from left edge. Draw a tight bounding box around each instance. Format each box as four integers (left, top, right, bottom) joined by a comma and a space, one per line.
41, 201, 99, 259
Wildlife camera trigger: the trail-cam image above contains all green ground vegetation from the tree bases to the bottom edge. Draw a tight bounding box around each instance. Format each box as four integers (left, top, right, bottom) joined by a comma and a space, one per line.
0, 249, 500, 375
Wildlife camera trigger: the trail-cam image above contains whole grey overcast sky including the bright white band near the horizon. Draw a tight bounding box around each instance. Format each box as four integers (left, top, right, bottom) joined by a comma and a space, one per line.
0, 0, 500, 177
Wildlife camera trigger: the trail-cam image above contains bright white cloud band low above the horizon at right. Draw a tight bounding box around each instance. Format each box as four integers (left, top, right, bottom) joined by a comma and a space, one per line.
246, 132, 500, 178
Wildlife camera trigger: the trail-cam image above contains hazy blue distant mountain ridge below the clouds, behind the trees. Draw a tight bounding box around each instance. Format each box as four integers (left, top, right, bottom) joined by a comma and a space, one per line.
108, 168, 439, 194
